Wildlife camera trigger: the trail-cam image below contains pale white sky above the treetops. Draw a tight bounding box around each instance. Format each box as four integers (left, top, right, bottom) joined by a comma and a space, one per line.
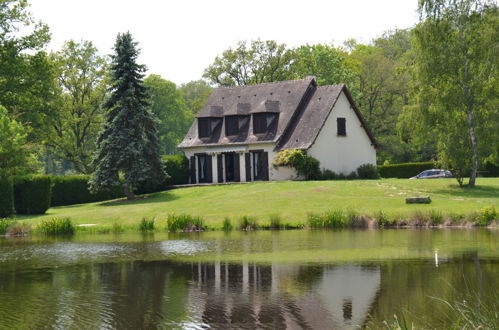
30, 0, 417, 84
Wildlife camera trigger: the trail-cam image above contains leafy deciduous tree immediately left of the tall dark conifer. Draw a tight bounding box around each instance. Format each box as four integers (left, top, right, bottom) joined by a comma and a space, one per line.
44, 40, 107, 174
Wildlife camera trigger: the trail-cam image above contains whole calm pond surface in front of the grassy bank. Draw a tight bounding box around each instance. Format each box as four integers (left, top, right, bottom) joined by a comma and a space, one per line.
0, 229, 499, 329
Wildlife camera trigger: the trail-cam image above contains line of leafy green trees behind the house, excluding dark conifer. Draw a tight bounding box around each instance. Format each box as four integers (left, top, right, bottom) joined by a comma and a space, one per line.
0, 0, 499, 185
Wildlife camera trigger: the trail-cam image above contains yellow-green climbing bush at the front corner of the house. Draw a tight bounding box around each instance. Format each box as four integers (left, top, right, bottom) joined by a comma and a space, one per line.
273, 149, 321, 180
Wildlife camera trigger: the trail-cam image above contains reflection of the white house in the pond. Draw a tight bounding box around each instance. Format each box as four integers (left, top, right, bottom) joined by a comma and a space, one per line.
188, 263, 381, 329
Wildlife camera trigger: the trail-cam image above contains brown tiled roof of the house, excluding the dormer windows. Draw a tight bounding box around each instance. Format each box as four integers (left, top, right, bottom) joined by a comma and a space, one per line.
179, 78, 376, 150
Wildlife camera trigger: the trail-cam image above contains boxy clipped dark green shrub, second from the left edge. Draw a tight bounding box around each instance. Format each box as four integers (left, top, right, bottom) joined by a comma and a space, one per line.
14, 175, 52, 214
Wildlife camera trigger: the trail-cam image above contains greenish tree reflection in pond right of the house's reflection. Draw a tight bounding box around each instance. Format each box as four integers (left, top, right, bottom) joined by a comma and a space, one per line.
365, 251, 499, 328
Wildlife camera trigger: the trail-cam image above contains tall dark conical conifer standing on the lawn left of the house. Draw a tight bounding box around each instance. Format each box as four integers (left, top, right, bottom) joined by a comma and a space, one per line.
90, 32, 165, 199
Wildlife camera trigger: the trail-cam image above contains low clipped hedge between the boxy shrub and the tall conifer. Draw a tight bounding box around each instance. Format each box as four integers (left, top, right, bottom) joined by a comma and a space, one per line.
50, 175, 124, 206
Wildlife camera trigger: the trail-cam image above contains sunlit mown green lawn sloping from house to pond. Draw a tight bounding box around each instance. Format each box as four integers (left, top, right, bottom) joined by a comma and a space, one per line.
18, 178, 499, 227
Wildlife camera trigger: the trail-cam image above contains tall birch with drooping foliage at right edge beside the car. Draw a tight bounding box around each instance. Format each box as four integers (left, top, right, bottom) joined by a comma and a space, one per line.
405, 0, 499, 186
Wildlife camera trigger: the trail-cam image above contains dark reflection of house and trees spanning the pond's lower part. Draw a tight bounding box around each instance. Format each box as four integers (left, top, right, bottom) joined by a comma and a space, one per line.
0, 255, 498, 329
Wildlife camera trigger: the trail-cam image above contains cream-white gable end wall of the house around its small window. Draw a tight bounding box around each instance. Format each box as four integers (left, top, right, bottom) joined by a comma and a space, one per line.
308, 92, 376, 174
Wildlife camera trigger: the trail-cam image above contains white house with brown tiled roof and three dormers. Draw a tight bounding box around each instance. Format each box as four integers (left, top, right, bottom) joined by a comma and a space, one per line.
179, 77, 377, 183
